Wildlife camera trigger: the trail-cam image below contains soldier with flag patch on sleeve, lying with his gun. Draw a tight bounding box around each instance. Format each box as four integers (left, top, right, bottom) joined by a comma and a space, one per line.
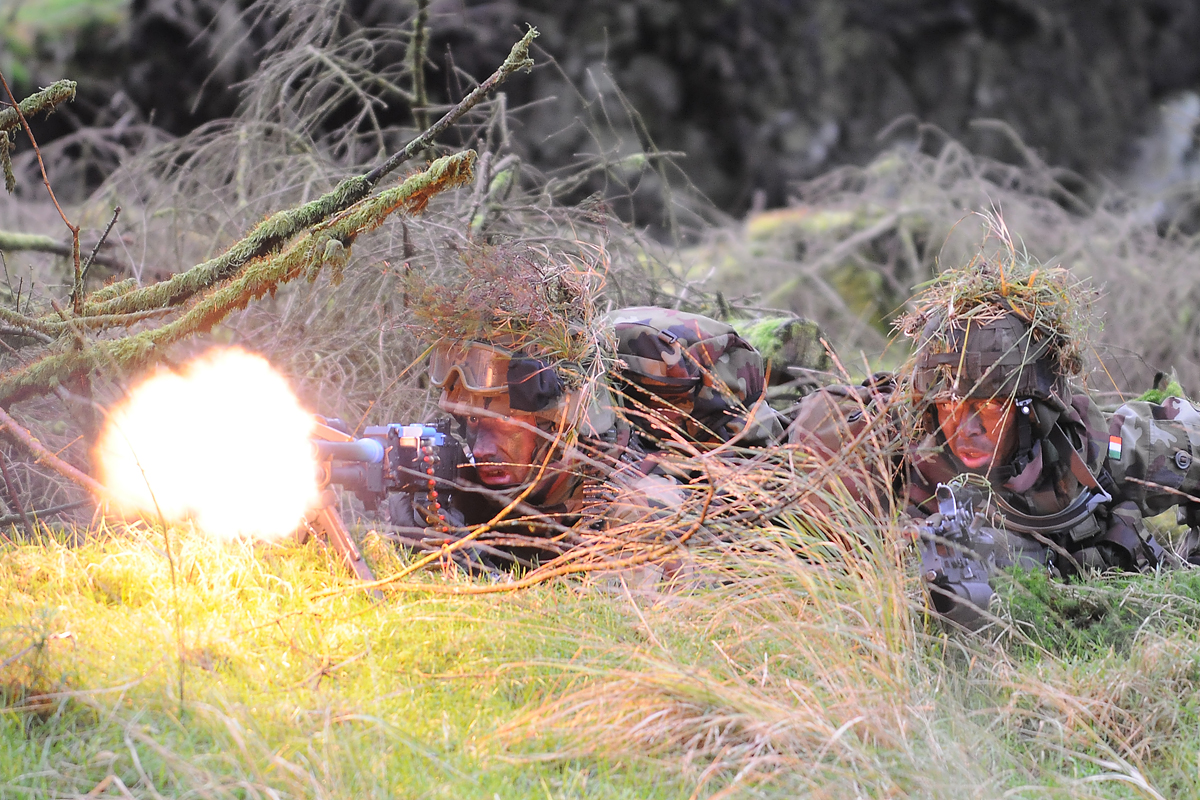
791, 262, 1200, 622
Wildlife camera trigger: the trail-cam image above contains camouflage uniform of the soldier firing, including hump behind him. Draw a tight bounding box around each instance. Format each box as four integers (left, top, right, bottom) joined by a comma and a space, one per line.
389, 307, 784, 554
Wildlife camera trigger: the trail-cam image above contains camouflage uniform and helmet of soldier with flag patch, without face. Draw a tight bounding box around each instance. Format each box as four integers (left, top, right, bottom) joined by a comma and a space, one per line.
790, 313, 1200, 612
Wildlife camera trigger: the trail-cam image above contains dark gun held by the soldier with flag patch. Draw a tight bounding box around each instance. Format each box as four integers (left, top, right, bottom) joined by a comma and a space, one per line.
917, 483, 997, 628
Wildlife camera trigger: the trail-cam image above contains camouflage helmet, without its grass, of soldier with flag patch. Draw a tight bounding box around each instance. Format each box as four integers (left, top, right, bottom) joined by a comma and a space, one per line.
912, 308, 1070, 410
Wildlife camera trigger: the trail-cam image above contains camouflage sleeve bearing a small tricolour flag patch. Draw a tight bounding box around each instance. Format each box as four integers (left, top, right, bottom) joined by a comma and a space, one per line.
1105, 397, 1200, 516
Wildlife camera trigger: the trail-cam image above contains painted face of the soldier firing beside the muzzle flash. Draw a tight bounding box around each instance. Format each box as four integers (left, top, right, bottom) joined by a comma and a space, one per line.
463, 395, 540, 488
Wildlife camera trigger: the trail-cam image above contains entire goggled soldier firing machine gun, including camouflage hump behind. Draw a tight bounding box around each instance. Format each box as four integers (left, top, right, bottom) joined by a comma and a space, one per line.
389, 307, 784, 549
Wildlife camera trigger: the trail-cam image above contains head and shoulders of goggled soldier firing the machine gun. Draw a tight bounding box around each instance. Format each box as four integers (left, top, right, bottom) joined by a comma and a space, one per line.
389, 339, 641, 549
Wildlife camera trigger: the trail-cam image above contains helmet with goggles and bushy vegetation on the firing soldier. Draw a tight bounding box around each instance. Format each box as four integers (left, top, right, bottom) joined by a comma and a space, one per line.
406, 243, 616, 437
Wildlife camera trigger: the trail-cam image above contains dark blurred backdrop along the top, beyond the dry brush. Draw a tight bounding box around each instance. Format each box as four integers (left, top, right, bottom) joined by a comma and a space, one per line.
7, 0, 1200, 215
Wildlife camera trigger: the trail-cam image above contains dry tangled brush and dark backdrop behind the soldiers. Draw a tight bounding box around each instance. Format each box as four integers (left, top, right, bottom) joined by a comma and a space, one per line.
0, 0, 1200, 413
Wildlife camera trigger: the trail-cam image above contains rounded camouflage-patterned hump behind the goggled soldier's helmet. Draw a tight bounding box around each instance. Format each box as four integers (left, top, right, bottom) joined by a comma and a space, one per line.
608, 306, 782, 444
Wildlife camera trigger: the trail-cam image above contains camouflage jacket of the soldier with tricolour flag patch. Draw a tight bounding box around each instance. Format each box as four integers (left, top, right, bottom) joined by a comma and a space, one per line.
790, 384, 1200, 575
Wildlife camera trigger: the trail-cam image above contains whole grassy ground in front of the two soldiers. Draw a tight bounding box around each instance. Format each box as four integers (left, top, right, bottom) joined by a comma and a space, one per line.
0, 515, 1200, 800
